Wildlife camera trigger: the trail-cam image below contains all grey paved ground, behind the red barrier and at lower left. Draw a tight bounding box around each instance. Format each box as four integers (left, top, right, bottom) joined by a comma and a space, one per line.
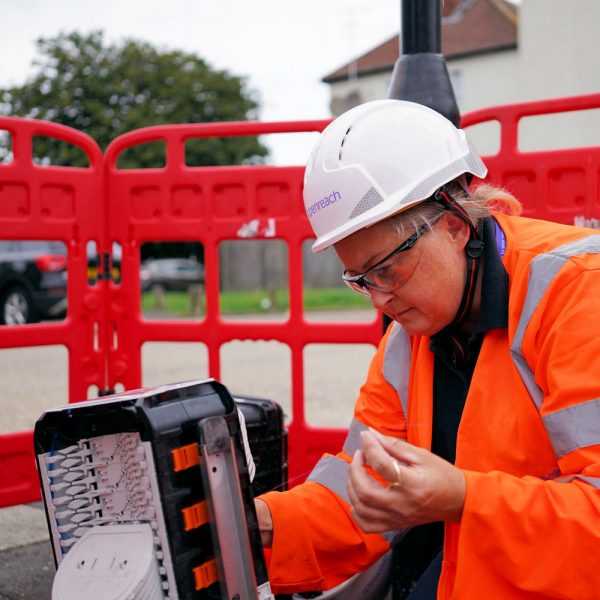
0, 311, 374, 600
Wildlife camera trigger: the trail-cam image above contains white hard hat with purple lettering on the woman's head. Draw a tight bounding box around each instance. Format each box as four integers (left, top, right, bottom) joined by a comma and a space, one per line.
304, 100, 487, 252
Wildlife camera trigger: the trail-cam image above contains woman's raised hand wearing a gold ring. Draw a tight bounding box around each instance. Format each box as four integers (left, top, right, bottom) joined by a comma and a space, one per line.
348, 431, 466, 533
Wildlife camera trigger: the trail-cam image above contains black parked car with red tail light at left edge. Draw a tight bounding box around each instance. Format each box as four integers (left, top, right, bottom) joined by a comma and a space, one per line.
0, 240, 67, 325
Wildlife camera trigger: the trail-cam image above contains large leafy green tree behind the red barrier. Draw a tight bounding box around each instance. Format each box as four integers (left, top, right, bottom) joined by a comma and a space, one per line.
0, 31, 267, 168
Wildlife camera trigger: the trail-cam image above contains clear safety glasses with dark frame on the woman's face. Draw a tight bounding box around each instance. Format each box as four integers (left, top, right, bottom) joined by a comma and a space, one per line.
342, 215, 441, 296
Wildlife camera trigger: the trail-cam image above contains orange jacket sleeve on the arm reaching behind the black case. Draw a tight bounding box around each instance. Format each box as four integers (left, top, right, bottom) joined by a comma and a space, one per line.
261, 324, 406, 593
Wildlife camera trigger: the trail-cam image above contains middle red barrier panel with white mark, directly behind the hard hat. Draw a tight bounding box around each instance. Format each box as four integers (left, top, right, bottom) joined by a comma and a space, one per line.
105, 121, 381, 488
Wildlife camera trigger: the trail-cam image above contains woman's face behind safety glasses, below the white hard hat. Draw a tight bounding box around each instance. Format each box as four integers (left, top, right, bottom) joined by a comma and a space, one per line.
334, 213, 469, 336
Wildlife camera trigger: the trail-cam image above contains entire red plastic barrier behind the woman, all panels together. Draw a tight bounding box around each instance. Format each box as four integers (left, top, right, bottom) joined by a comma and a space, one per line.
0, 94, 600, 506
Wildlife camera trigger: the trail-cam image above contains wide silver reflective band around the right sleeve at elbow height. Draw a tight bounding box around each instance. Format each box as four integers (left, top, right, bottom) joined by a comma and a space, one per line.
542, 399, 600, 457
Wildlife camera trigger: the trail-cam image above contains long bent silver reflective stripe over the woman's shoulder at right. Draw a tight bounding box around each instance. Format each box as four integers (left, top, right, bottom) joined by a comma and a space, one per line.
510, 235, 600, 410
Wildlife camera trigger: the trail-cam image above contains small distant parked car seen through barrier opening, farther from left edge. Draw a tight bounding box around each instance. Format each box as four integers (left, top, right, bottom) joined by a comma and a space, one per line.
140, 258, 204, 291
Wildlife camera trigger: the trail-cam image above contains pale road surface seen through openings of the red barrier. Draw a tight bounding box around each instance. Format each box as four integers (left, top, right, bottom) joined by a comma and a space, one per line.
0, 311, 374, 433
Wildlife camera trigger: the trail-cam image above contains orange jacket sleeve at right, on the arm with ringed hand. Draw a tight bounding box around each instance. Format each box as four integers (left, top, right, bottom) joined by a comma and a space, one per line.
456, 264, 600, 600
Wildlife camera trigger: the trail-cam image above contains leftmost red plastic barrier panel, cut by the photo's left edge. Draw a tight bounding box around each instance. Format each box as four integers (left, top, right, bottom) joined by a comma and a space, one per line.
0, 118, 106, 506
